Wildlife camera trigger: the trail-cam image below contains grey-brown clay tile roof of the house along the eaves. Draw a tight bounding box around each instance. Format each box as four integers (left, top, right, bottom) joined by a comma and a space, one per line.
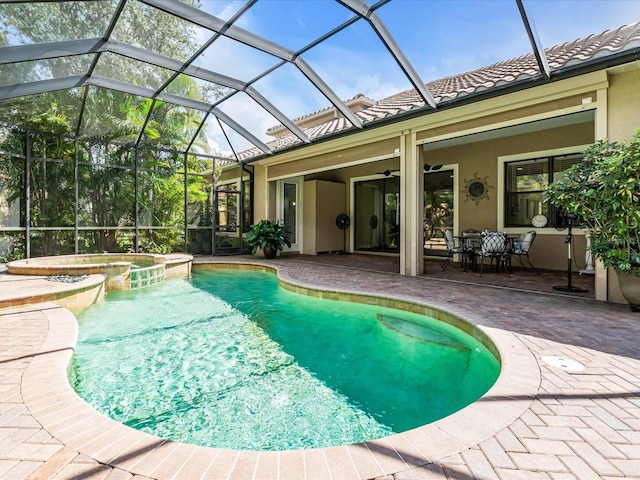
238, 22, 640, 161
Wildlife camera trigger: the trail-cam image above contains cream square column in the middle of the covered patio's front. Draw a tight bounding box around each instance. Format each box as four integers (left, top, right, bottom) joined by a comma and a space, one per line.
400, 132, 424, 277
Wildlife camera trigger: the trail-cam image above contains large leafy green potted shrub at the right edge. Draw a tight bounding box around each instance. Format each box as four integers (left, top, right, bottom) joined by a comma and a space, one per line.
544, 130, 640, 312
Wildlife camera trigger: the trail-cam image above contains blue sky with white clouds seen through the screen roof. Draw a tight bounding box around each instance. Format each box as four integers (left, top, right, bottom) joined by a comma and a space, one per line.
188, 0, 640, 156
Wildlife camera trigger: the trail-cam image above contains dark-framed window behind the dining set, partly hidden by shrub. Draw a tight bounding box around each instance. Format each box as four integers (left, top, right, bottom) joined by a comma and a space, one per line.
504, 153, 582, 227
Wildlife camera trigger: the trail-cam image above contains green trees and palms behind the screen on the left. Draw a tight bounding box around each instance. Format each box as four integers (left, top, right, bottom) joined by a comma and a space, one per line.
0, 1, 223, 255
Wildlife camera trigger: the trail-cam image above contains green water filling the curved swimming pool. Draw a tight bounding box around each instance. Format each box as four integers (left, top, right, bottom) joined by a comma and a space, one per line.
69, 271, 500, 450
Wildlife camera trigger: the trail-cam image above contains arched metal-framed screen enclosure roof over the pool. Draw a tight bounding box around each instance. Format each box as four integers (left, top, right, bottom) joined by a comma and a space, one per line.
0, 0, 640, 162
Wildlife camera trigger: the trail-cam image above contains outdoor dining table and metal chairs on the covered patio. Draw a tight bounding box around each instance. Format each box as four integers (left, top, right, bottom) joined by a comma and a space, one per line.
442, 229, 538, 274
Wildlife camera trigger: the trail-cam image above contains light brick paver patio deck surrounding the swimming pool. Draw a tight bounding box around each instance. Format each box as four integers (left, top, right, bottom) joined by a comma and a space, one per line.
0, 257, 640, 480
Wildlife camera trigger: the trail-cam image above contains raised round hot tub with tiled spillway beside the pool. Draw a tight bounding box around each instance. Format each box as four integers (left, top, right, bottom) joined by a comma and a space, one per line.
7, 253, 193, 292
